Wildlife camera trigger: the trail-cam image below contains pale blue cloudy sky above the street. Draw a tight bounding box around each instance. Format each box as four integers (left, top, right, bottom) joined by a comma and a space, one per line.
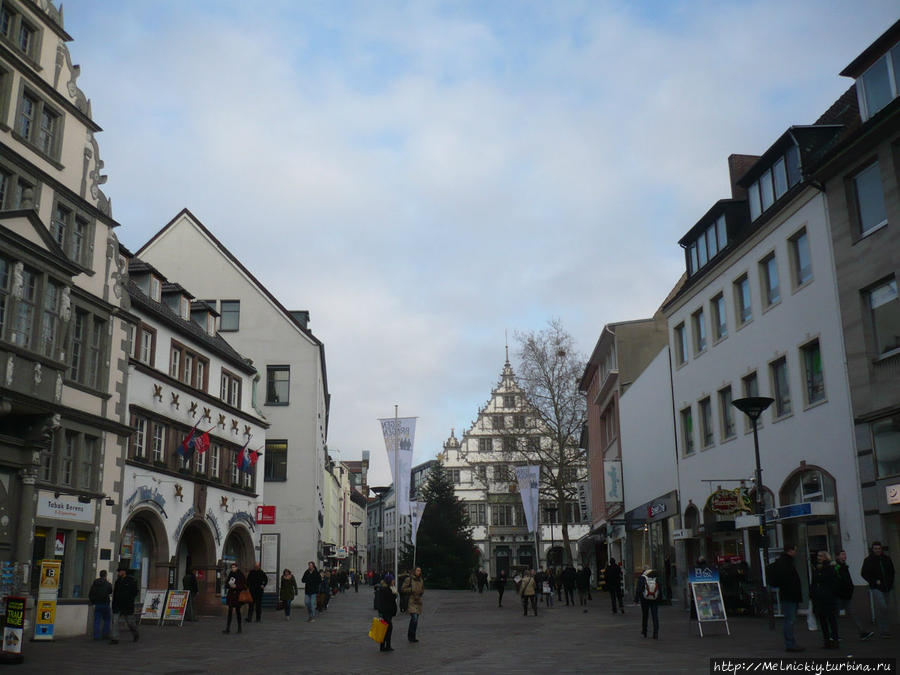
59, 0, 900, 485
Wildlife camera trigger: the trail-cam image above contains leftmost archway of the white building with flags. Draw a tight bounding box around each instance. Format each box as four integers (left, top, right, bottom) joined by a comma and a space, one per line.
119, 507, 169, 598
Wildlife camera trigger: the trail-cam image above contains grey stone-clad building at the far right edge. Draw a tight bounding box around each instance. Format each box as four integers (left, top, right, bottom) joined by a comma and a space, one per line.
815, 21, 900, 609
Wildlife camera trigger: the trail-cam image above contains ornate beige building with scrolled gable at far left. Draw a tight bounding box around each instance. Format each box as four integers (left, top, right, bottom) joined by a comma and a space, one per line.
0, 0, 131, 636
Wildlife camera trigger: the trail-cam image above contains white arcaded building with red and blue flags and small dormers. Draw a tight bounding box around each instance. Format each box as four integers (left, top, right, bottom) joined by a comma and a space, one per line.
117, 257, 268, 612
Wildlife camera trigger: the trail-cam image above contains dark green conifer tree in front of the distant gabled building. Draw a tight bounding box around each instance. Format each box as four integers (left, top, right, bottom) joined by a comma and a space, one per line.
401, 463, 477, 588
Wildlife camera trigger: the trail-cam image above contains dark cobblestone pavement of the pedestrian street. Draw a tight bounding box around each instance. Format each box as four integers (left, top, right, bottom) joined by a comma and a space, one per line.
3, 588, 900, 675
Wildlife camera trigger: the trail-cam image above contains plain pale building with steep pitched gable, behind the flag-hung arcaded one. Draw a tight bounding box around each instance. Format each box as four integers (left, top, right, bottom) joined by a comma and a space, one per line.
138, 209, 330, 592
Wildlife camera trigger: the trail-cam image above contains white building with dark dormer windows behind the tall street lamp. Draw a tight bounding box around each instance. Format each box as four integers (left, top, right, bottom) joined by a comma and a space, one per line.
663, 143, 865, 596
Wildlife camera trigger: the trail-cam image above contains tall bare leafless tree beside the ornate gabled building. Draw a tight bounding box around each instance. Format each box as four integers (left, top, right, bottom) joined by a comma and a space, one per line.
516, 319, 588, 561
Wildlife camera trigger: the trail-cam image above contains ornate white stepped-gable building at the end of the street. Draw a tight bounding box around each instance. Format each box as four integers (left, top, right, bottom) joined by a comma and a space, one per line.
441, 360, 589, 577
